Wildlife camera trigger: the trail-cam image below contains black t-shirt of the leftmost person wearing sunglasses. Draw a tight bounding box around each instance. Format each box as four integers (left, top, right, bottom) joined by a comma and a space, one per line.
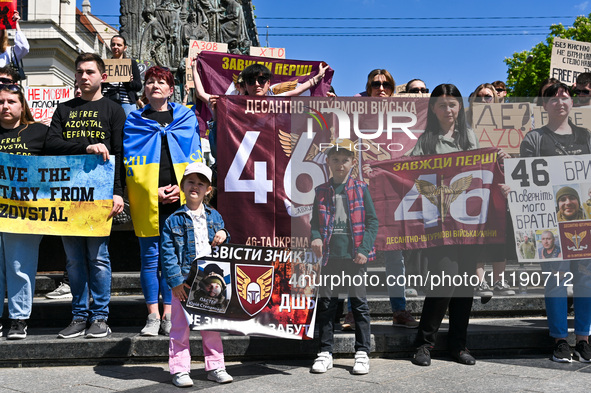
0, 123, 49, 156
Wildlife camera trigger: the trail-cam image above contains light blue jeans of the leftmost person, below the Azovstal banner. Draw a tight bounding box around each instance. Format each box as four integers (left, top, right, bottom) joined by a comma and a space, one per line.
0, 233, 43, 319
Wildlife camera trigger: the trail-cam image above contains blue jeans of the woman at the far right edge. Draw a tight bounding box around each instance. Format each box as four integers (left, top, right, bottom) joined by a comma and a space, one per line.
541, 259, 591, 338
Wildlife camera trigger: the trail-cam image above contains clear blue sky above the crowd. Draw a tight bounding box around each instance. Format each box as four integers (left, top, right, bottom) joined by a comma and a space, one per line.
76, 0, 591, 96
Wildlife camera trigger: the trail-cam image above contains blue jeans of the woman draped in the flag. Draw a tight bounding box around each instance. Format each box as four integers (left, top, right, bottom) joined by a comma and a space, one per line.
138, 236, 172, 304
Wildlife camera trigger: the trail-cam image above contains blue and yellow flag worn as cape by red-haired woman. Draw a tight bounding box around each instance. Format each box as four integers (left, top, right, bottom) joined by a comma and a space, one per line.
123, 103, 203, 237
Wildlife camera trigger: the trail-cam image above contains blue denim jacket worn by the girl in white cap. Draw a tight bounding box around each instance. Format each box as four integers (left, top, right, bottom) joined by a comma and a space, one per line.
160, 204, 230, 288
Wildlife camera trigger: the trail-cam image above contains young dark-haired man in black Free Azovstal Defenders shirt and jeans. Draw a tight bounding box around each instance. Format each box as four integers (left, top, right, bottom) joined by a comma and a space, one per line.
47, 53, 125, 338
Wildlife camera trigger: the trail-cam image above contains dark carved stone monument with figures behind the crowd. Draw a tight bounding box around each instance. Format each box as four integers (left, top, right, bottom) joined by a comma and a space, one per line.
120, 0, 259, 72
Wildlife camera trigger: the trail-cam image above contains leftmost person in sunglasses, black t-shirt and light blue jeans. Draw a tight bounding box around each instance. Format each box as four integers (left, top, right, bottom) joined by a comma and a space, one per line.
0, 84, 48, 340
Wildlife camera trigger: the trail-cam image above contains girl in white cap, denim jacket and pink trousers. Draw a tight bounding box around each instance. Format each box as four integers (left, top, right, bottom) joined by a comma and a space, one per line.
161, 162, 233, 387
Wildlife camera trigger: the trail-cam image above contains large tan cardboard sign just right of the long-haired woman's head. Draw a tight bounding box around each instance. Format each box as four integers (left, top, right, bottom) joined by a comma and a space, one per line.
472, 102, 532, 153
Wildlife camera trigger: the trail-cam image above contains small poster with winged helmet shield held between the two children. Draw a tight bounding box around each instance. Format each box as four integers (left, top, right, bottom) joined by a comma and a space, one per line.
181, 244, 321, 340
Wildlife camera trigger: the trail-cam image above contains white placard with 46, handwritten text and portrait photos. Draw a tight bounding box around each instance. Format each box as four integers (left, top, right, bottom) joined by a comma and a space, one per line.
505, 154, 591, 262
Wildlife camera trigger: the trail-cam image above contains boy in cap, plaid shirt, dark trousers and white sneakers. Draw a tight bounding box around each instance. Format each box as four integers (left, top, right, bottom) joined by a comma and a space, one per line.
310, 140, 378, 375
